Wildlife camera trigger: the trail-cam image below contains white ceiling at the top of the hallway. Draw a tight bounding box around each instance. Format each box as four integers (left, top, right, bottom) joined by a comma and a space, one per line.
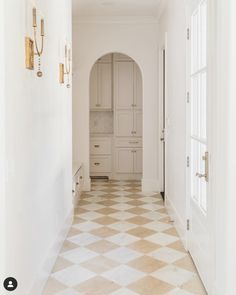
73, 0, 161, 17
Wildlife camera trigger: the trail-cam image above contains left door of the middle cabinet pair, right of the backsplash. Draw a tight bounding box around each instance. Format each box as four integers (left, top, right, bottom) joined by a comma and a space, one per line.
116, 111, 134, 137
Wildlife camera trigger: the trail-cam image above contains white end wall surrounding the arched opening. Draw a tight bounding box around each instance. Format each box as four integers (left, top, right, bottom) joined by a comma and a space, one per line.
73, 21, 159, 191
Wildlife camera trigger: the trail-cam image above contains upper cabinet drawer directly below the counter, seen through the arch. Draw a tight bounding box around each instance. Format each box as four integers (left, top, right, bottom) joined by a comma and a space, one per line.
90, 138, 112, 155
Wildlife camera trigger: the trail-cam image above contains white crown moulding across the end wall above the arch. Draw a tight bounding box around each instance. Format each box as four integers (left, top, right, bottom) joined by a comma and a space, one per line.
73, 15, 158, 25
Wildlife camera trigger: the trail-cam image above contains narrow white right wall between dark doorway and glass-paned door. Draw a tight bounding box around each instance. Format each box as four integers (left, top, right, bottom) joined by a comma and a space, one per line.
160, 0, 186, 243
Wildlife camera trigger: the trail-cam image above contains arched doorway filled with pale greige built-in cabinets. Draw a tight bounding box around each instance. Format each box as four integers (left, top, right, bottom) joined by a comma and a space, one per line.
90, 53, 143, 180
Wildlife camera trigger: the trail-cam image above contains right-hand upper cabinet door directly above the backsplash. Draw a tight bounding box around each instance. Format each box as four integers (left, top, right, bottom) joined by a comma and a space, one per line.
98, 63, 112, 110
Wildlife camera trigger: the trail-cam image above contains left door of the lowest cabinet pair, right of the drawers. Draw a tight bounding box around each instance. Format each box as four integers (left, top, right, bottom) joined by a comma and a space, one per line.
116, 148, 134, 173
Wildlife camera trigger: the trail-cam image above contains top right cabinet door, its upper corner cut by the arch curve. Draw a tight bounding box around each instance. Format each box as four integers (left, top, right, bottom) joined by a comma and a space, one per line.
134, 63, 143, 110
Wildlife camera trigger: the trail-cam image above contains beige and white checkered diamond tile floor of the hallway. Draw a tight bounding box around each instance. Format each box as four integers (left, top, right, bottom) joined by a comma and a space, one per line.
43, 181, 206, 295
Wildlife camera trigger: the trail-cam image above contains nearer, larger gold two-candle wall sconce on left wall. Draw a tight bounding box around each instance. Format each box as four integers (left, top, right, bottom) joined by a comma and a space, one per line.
25, 8, 44, 77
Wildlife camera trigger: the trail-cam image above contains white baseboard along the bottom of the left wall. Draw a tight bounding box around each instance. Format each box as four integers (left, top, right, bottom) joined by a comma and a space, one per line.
28, 210, 74, 295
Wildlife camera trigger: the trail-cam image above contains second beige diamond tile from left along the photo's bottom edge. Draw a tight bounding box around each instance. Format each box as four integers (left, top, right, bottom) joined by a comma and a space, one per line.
75, 276, 120, 295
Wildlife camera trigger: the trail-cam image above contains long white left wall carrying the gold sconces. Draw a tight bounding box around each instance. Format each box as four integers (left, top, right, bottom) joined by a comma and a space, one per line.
1, 0, 72, 295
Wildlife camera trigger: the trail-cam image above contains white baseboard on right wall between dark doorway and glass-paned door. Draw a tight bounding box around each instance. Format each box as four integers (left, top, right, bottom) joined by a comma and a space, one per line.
165, 195, 187, 249
